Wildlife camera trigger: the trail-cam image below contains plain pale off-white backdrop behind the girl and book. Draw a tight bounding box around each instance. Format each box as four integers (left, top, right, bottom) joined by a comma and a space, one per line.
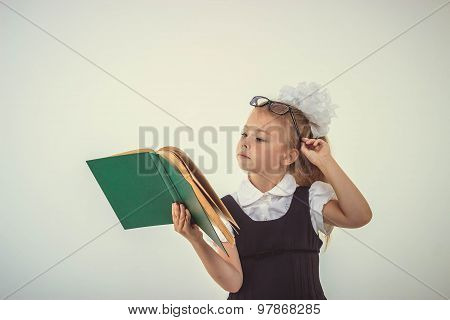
0, 0, 450, 299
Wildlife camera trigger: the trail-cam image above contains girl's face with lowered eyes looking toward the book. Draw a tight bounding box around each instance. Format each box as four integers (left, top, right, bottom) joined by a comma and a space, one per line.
236, 108, 299, 175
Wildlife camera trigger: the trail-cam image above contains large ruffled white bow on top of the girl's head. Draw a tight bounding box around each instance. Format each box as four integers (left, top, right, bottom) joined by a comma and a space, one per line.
278, 81, 339, 138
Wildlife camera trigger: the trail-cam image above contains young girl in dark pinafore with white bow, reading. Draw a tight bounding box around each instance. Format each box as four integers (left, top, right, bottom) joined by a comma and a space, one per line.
172, 82, 372, 300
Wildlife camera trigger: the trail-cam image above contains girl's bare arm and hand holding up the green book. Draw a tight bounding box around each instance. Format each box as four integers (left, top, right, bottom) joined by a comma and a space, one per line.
172, 203, 243, 292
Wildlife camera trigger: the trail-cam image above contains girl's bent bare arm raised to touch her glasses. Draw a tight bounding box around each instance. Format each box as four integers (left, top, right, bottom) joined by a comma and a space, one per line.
301, 138, 372, 228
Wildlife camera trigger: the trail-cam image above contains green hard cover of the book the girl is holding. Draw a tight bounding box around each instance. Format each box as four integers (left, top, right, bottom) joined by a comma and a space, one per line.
86, 152, 229, 256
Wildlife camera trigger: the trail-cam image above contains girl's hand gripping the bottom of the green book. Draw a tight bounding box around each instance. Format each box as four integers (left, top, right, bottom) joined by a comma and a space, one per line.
172, 202, 203, 243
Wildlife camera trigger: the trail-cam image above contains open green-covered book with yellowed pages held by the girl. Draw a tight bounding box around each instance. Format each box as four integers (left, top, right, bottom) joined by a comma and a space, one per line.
86, 146, 239, 255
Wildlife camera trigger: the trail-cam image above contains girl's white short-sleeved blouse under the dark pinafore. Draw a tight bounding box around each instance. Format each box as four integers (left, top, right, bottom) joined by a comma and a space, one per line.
204, 173, 337, 247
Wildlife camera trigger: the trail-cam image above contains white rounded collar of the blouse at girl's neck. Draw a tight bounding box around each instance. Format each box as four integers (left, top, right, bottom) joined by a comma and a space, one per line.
237, 173, 298, 206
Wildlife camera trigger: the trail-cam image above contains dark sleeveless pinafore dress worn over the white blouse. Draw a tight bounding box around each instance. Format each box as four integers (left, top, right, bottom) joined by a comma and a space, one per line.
221, 186, 326, 300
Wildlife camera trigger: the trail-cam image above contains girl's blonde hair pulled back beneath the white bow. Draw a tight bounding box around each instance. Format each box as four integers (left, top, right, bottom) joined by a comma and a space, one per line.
263, 106, 331, 250
